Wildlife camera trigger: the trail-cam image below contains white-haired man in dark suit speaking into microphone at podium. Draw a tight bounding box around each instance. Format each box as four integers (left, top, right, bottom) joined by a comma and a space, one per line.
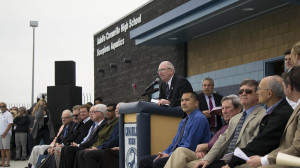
157, 61, 193, 107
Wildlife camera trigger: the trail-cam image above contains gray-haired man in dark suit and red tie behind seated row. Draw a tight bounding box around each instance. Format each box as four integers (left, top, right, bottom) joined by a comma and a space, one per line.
198, 77, 223, 132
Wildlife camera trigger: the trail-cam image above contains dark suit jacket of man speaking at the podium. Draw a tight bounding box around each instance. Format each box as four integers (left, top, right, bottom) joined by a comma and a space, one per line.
159, 74, 193, 106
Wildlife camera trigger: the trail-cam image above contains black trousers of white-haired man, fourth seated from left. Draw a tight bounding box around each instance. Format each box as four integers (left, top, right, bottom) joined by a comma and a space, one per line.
62, 146, 86, 168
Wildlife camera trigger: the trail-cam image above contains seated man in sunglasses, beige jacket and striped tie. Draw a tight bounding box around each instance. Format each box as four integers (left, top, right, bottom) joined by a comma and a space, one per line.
187, 79, 266, 168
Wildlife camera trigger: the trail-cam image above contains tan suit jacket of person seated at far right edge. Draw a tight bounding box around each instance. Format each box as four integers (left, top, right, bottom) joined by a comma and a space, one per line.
268, 105, 300, 164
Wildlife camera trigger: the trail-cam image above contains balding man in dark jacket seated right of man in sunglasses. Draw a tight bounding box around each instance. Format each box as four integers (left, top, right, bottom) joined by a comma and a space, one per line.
224, 76, 293, 167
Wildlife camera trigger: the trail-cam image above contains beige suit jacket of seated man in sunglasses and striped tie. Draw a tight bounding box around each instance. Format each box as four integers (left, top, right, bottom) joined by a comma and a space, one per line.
202, 106, 266, 163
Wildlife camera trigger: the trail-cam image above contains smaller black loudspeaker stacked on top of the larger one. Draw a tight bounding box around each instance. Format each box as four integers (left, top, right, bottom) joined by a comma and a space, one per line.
55, 61, 76, 86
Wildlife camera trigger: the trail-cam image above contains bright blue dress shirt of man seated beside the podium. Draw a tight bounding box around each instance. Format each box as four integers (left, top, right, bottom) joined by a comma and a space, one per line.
163, 108, 211, 155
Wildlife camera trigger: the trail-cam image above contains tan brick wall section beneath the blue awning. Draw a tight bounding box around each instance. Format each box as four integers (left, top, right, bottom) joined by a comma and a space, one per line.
187, 6, 300, 76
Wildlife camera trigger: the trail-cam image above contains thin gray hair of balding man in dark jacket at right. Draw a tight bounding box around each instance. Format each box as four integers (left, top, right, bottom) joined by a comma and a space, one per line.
269, 76, 285, 99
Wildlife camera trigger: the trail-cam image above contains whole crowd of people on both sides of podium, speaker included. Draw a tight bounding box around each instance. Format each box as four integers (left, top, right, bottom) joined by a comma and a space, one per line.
0, 42, 300, 168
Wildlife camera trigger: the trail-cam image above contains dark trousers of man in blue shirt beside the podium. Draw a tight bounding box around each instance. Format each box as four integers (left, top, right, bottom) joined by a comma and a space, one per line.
139, 155, 169, 168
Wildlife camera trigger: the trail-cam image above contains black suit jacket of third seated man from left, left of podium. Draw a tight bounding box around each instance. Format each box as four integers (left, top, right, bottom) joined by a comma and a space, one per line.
67, 119, 94, 145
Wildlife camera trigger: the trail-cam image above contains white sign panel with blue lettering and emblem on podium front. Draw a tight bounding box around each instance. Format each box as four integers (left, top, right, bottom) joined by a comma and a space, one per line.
124, 123, 137, 168
